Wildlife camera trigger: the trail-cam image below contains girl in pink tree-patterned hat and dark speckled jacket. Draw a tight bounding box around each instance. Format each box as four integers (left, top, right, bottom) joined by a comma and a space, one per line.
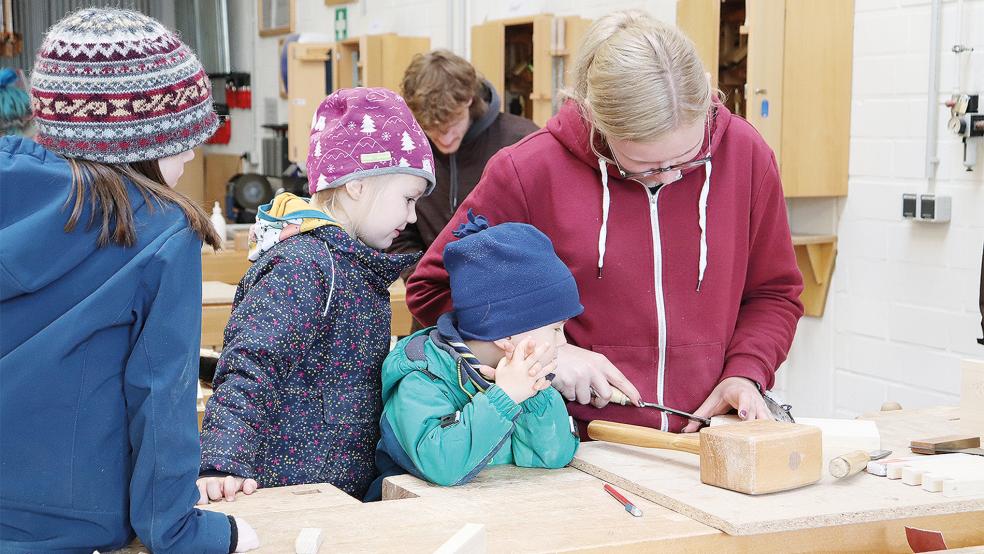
199, 88, 434, 500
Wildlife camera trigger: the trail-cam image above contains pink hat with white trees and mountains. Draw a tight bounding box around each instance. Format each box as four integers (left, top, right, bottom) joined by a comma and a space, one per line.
307, 87, 435, 194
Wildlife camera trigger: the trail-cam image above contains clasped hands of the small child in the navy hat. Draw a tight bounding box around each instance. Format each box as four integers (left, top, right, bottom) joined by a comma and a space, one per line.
495, 338, 557, 404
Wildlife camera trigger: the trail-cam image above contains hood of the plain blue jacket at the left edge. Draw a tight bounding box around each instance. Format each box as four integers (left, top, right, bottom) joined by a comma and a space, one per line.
0, 136, 129, 300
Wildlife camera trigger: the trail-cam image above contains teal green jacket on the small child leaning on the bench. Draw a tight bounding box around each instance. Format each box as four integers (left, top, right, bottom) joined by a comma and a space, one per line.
367, 314, 579, 492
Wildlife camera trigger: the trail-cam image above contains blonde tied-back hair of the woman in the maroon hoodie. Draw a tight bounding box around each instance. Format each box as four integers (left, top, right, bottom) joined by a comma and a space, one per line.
564, 10, 712, 142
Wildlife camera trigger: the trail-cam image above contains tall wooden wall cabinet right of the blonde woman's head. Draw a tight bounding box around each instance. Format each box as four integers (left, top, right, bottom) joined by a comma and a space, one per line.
677, 0, 854, 198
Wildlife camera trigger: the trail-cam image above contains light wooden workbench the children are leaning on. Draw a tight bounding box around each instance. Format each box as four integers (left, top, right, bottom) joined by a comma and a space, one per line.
132, 408, 984, 553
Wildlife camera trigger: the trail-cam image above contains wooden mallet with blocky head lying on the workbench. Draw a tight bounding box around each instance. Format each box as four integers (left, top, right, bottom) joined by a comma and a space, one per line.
588, 420, 822, 494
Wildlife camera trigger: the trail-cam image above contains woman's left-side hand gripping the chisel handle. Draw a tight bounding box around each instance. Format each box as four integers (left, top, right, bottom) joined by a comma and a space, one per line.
553, 344, 641, 408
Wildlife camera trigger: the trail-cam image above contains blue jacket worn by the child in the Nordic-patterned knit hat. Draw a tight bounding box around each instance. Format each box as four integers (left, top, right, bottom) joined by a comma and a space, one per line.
0, 137, 230, 554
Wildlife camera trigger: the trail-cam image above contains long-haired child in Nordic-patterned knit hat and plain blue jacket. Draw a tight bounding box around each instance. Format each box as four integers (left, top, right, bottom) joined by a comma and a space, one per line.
0, 9, 258, 554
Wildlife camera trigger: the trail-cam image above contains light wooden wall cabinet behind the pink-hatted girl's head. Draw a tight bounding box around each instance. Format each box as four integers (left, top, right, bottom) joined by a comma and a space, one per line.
287, 33, 430, 162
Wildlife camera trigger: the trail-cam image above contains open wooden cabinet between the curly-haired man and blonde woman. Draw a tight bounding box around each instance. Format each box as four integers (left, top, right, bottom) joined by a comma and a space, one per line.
471, 14, 591, 127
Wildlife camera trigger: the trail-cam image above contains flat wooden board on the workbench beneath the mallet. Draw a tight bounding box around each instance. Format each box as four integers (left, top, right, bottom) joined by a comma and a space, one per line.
571, 408, 984, 535
